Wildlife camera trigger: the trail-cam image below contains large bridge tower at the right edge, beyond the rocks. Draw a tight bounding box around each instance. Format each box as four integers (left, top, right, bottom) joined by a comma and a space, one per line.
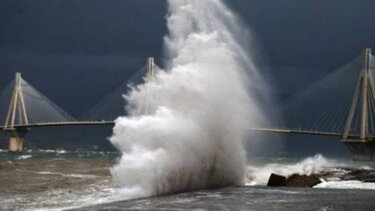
341, 48, 375, 160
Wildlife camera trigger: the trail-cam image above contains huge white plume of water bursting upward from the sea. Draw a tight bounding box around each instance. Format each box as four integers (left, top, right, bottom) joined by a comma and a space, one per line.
110, 0, 261, 197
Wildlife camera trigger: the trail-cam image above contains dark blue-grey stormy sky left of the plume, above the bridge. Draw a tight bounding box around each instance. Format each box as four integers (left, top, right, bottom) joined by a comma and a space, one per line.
0, 0, 166, 115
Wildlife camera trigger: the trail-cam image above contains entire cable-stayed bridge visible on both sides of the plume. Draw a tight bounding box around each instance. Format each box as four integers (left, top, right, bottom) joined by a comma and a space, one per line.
0, 49, 375, 160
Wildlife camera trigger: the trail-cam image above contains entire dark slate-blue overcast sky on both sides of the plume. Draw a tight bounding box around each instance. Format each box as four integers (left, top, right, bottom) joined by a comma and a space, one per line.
0, 0, 375, 115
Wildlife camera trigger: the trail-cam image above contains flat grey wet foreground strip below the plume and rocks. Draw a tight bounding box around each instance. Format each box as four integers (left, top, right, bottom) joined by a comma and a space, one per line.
89, 186, 375, 211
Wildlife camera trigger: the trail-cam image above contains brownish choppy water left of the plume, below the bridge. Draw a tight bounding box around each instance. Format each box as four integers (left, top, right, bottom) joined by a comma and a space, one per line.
0, 152, 117, 210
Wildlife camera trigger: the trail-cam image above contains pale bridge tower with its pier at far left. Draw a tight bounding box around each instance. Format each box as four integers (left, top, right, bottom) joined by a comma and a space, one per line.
4, 73, 29, 152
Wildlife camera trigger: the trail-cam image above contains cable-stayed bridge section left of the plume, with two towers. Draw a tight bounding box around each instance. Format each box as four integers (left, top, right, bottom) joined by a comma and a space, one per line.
0, 58, 158, 152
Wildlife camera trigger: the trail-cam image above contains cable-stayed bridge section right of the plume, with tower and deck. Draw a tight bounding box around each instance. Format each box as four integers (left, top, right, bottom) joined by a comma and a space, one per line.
253, 48, 375, 160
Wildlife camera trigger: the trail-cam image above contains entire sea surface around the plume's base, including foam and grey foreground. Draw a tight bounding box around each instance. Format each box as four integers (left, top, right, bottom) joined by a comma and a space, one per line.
0, 151, 375, 210
